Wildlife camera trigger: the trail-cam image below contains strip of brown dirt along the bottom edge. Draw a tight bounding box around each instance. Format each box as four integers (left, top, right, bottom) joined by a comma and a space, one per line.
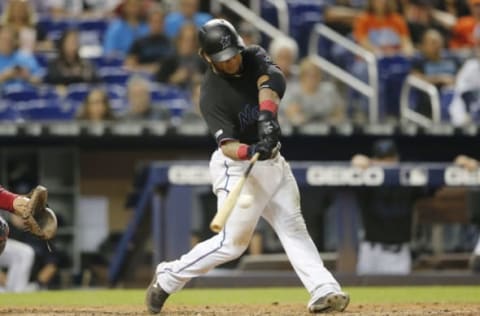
0, 303, 480, 316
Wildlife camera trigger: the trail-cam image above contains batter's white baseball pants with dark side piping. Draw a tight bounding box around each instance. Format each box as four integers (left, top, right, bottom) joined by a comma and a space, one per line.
156, 149, 340, 304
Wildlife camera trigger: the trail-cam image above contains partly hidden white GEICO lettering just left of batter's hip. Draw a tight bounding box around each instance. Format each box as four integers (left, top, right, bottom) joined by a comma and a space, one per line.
168, 165, 211, 185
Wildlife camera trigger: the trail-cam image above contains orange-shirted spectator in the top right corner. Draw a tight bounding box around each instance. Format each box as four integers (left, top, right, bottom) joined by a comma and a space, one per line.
450, 0, 480, 50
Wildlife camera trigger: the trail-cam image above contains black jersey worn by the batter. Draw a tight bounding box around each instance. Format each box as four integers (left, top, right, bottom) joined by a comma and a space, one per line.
200, 45, 277, 145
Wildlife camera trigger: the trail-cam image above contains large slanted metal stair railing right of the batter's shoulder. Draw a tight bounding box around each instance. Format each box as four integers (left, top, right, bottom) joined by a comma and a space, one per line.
308, 23, 378, 123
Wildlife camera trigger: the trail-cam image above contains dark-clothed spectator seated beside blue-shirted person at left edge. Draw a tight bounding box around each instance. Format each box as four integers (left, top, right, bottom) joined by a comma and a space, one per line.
45, 30, 98, 87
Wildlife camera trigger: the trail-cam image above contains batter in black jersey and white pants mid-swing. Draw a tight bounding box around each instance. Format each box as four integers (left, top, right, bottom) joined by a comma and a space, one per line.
146, 19, 349, 314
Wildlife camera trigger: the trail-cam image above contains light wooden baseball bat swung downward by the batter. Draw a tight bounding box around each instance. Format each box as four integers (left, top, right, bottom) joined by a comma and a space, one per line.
210, 153, 260, 233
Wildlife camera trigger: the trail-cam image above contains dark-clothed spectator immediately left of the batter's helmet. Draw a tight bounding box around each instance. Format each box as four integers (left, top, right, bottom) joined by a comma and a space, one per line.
156, 24, 206, 89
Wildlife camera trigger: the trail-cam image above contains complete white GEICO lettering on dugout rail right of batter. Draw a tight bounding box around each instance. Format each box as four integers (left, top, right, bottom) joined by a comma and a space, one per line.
306, 167, 385, 186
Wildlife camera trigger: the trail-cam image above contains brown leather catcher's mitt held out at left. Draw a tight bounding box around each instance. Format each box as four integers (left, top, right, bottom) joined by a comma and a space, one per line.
22, 185, 58, 240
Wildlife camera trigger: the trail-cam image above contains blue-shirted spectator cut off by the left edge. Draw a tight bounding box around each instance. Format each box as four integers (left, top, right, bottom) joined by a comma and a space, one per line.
0, 27, 41, 87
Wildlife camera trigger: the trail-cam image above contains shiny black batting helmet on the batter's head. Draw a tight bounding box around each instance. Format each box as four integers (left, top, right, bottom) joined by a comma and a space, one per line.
198, 19, 244, 62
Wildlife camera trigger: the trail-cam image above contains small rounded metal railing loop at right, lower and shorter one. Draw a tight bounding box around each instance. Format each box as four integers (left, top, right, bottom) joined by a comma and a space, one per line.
400, 75, 440, 128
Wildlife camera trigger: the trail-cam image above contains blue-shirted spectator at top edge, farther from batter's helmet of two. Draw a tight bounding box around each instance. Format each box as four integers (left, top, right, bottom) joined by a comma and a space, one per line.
103, 0, 148, 57
